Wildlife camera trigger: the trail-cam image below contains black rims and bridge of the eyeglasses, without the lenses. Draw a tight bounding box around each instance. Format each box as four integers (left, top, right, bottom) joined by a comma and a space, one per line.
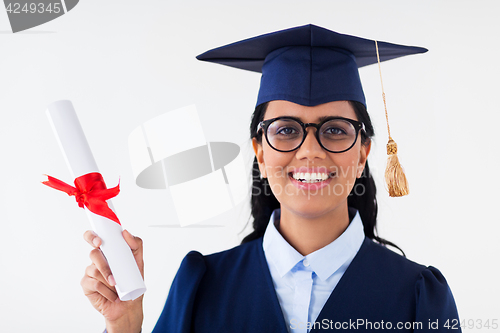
257, 116, 366, 154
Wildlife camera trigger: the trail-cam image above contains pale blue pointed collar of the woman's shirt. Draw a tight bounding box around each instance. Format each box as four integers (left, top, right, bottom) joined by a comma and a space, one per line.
262, 208, 365, 281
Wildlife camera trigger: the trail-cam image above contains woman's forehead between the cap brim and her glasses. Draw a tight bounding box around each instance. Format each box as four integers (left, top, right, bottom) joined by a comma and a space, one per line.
264, 100, 358, 123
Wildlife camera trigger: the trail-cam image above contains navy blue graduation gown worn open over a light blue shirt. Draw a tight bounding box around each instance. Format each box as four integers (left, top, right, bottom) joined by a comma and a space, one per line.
153, 238, 460, 333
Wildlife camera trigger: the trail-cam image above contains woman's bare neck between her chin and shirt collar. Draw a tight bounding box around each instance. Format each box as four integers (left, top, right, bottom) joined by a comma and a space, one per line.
279, 204, 349, 256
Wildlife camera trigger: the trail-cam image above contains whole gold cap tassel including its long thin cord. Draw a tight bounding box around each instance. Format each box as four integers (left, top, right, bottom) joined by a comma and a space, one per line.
375, 41, 410, 197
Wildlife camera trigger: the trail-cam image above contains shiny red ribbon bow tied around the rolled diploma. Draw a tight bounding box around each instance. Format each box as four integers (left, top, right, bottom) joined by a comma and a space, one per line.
42, 172, 121, 225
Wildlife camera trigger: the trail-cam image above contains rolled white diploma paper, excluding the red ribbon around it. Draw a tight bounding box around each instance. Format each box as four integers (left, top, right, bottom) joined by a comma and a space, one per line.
47, 100, 146, 301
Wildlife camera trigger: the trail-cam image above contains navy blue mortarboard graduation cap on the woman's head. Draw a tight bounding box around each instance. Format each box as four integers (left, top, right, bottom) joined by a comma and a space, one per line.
197, 24, 427, 106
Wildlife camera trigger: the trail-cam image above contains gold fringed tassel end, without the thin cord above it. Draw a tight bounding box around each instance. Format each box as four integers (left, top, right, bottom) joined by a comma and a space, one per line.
385, 138, 410, 197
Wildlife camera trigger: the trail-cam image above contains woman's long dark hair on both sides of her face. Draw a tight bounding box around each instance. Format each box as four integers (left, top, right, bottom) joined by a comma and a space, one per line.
241, 101, 405, 255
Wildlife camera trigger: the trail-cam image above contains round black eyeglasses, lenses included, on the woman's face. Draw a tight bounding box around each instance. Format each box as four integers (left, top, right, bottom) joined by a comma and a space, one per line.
257, 116, 366, 153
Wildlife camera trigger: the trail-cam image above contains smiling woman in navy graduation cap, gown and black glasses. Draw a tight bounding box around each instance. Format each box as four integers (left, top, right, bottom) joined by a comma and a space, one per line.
82, 25, 460, 332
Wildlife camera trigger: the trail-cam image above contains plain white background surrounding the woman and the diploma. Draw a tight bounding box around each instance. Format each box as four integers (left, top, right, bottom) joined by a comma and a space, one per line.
0, 0, 500, 332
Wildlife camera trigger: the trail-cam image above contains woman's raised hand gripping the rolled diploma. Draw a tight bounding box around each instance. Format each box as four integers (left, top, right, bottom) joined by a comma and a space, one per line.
80, 230, 144, 333
